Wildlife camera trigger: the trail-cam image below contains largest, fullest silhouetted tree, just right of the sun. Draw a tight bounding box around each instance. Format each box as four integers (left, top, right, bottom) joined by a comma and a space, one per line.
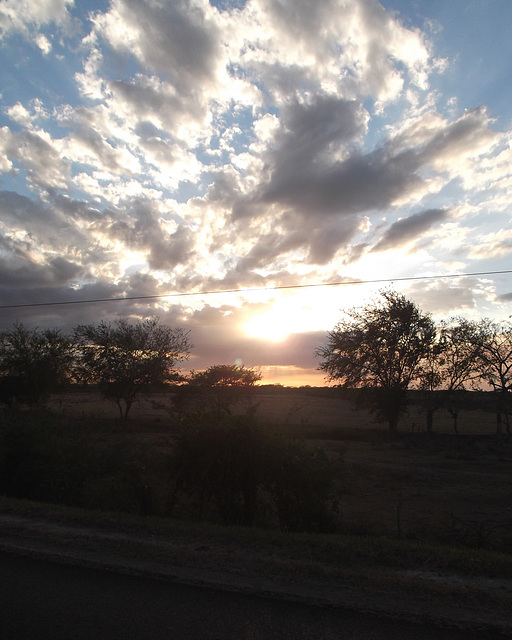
317, 290, 436, 431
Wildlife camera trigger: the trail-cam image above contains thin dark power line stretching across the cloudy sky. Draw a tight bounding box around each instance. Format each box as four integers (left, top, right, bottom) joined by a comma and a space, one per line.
0, 269, 512, 309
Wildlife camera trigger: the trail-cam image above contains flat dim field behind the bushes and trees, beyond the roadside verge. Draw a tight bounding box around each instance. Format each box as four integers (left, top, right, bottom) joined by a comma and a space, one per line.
43, 392, 512, 551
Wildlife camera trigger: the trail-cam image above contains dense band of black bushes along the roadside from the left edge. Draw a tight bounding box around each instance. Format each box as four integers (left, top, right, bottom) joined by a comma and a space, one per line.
0, 410, 344, 532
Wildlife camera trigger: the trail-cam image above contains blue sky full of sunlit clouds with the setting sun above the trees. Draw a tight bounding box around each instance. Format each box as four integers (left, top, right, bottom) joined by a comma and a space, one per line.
0, 0, 512, 386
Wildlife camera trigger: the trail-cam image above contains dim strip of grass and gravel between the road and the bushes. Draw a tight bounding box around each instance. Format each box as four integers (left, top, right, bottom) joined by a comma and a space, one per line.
0, 512, 512, 637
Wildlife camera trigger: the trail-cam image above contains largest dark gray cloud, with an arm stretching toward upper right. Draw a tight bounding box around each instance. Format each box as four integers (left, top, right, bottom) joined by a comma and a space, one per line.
233, 105, 494, 224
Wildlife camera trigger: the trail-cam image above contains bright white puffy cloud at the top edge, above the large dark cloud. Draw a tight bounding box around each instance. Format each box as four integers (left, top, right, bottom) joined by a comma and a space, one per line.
242, 0, 432, 103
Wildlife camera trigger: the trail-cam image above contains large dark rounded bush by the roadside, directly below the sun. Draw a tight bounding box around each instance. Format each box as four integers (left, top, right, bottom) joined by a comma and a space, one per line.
174, 414, 336, 532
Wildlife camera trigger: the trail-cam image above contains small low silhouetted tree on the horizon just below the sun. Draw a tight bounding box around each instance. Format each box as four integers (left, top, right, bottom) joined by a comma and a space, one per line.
189, 364, 261, 415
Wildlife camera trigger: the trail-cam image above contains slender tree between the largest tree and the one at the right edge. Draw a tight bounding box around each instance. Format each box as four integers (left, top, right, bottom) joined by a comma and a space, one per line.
418, 318, 481, 433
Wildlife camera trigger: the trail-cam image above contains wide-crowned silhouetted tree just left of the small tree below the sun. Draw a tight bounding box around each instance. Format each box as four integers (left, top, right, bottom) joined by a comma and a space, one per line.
75, 318, 192, 420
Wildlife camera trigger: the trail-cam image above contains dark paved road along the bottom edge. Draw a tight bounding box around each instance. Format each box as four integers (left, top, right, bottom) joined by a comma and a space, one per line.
0, 553, 502, 640
